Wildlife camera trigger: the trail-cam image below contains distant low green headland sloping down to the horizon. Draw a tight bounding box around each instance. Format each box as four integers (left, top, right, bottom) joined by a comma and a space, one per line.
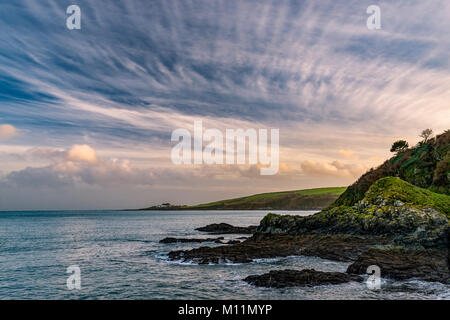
138, 187, 346, 210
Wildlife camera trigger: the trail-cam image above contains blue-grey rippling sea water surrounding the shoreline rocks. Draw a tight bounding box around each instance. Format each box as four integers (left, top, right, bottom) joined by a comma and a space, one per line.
0, 211, 450, 299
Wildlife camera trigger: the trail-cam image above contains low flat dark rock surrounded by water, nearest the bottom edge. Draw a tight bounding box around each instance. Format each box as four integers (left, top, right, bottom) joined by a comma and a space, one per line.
244, 269, 363, 288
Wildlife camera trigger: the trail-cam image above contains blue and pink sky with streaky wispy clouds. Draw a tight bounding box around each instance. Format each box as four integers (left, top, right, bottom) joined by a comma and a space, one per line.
0, 0, 450, 210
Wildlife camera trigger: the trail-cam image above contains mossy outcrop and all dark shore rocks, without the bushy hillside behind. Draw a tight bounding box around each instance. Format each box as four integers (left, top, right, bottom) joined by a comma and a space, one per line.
160, 178, 450, 288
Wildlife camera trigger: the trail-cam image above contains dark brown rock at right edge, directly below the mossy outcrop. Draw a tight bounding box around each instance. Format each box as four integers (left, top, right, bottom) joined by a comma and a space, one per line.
347, 248, 450, 283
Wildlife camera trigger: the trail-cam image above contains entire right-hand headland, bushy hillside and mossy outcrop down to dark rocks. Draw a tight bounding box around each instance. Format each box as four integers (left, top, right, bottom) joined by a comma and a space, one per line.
158, 130, 450, 287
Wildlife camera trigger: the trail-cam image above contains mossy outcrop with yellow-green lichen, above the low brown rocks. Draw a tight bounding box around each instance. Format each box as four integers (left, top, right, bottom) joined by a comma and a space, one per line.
258, 177, 450, 247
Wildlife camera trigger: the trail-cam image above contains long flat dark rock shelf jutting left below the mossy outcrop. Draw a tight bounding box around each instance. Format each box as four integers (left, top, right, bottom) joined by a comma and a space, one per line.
169, 233, 389, 264
